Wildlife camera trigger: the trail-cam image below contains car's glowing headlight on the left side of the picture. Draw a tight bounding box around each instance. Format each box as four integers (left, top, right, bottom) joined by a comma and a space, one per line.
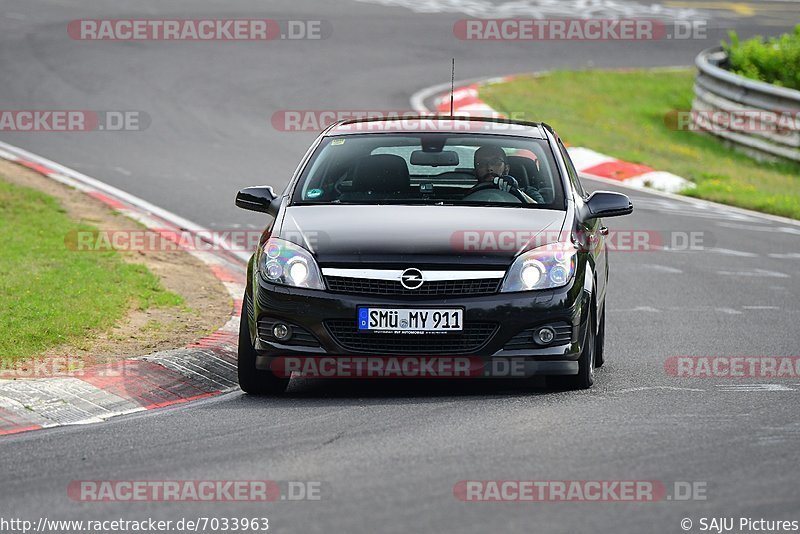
260, 237, 325, 289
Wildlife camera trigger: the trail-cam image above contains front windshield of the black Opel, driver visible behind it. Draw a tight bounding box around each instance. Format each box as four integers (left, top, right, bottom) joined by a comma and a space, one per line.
292, 133, 564, 210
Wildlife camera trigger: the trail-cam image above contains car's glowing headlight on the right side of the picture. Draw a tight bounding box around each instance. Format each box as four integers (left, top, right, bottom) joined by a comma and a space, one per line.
500, 243, 578, 293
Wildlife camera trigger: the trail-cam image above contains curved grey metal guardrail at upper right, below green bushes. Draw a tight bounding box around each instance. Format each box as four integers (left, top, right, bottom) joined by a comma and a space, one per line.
692, 47, 800, 162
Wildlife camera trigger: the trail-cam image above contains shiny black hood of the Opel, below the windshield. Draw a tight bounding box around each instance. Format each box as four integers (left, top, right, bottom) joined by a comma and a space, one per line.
278, 205, 566, 267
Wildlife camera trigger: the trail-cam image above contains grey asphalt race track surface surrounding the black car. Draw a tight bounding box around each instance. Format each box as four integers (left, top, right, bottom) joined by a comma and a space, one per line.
0, 0, 800, 532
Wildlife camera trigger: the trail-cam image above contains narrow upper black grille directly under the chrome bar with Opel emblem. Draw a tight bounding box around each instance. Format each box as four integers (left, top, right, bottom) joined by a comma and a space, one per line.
325, 276, 502, 297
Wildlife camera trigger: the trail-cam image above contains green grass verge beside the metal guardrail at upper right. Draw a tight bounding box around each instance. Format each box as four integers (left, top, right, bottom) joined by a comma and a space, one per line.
481, 69, 800, 219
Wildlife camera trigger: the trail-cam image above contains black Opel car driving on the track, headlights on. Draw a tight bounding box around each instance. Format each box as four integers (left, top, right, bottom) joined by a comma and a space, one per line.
236, 117, 633, 393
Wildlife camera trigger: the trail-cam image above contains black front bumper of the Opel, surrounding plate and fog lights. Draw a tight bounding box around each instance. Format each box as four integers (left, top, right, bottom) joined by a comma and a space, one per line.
247, 270, 591, 375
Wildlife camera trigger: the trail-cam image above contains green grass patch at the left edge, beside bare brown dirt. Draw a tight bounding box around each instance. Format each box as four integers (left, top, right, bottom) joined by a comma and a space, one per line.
0, 177, 183, 362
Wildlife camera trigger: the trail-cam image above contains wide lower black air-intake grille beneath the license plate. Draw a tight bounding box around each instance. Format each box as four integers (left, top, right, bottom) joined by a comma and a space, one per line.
325, 319, 497, 354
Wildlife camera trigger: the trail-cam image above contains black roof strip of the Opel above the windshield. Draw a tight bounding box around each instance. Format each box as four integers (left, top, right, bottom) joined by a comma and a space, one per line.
323, 114, 552, 139
